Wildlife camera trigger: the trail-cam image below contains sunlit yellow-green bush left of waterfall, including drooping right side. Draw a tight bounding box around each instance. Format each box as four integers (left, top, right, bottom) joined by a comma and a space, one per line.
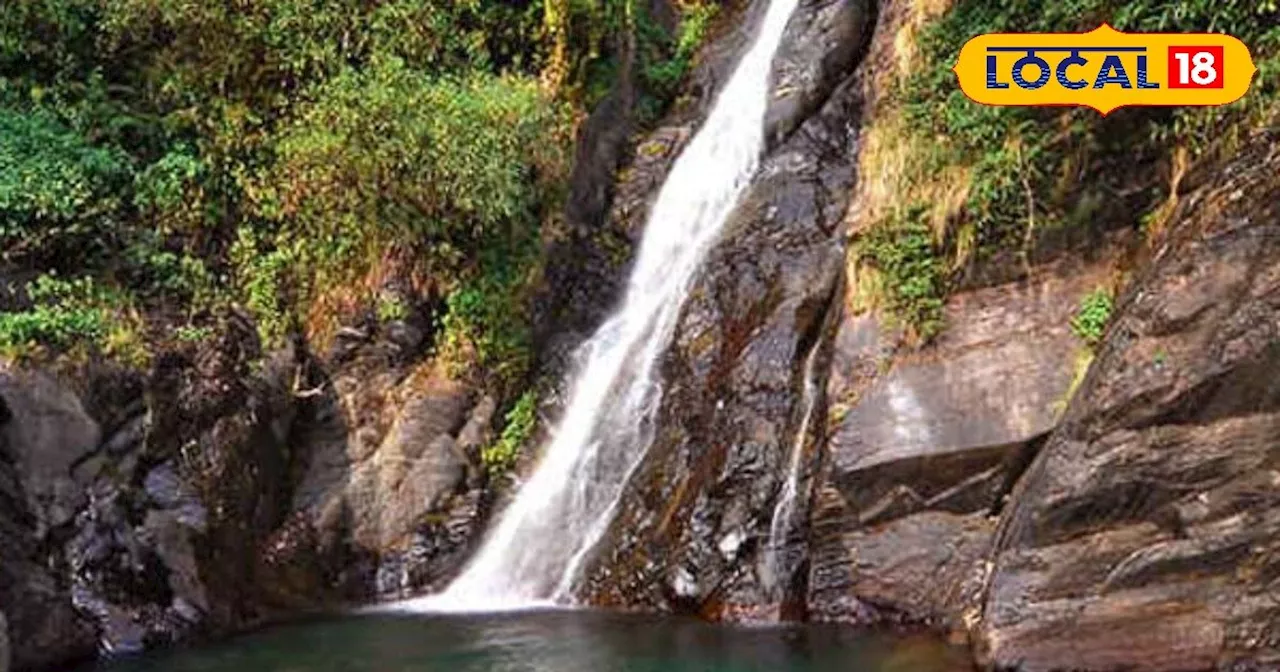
249, 59, 568, 345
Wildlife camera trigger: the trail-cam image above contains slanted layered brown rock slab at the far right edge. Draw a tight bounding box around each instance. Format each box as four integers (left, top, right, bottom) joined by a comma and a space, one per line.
980, 136, 1280, 671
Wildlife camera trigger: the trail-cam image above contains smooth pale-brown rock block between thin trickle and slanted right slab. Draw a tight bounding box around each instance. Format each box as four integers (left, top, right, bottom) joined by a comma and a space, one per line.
809, 260, 1110, 628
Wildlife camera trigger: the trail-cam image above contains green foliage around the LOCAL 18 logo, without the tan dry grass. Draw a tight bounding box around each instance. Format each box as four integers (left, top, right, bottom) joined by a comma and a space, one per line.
897, 0, 1280, 259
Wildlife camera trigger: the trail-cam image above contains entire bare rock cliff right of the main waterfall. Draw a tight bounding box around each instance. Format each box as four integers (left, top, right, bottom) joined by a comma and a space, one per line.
570, 3, 1280, 669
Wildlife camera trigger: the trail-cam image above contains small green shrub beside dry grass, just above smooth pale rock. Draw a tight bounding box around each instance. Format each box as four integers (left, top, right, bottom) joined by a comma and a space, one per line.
855, 209, 946, 340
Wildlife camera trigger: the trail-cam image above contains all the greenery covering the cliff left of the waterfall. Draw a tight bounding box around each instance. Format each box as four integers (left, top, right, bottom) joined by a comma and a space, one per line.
0, 0, 716, 465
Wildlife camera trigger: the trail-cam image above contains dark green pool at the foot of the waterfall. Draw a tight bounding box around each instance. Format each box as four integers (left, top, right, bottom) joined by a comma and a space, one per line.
91, 612, 970, 672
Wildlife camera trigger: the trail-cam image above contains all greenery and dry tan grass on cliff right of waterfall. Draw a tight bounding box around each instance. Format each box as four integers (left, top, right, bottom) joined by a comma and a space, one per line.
852, 0, 1280, 340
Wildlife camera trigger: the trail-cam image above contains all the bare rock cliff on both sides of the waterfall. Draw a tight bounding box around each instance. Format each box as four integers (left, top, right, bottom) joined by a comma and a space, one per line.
0, 0, 1280, 672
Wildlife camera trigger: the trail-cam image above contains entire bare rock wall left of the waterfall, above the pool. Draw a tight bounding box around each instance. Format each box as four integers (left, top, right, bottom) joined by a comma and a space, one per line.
0, 309, 495, 669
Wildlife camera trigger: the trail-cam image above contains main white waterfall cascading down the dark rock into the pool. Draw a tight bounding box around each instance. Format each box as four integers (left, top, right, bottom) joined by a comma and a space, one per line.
407, 0, 797, 611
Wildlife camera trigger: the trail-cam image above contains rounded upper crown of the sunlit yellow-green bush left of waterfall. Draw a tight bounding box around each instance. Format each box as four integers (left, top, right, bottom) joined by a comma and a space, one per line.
257, 59, 559, 269
